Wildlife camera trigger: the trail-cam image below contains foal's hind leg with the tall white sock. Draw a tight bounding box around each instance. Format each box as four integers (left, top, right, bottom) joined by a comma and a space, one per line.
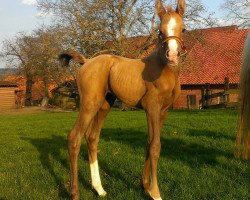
86, 101, 110, 196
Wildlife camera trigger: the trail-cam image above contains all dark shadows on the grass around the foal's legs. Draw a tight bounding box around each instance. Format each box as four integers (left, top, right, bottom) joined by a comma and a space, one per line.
21, 128, 246, 199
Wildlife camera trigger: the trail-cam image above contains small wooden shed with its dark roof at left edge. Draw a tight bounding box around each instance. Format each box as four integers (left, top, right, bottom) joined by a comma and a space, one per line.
0, 81, 17, 111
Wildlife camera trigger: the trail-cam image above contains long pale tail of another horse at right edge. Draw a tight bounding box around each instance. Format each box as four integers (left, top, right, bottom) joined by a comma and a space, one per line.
235, 33, 250, 160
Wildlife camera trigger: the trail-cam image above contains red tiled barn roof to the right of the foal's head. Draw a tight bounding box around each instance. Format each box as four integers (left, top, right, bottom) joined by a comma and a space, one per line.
180, 26, 250, 85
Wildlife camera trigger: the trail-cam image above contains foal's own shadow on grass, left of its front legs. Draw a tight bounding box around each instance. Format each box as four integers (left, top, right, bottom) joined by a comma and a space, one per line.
21, 135, 147, 199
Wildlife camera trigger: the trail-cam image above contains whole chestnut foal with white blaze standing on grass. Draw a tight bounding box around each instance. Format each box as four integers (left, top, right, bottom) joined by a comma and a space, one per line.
59, 0, 185, 200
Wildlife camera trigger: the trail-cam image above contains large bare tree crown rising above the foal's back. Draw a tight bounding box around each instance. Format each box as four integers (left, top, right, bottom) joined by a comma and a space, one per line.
38, 0, 155, 56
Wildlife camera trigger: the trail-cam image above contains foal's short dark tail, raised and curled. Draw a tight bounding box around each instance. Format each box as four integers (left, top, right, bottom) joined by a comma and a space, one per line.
58, 50, 88, 67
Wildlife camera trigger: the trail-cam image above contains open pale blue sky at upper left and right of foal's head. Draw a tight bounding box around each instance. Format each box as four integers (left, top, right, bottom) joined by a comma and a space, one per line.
0, 0, 224, 67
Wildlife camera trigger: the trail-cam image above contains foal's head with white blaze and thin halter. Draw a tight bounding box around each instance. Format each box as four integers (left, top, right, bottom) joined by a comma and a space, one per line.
156, 0, 186, 65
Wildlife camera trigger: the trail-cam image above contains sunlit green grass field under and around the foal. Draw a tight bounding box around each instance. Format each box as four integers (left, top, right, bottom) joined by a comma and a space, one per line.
0, 110, 250, 200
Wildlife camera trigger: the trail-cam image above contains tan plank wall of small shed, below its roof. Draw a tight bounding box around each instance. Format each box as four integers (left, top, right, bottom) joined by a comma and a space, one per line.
0, 87, 16, 110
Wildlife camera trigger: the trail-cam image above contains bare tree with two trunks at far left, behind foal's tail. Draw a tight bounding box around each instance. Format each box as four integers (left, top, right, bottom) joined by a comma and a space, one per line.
1, 28, 66, 106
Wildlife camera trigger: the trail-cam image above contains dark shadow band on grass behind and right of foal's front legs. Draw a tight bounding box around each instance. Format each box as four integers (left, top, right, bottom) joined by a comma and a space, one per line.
101, 129, 233, 167
